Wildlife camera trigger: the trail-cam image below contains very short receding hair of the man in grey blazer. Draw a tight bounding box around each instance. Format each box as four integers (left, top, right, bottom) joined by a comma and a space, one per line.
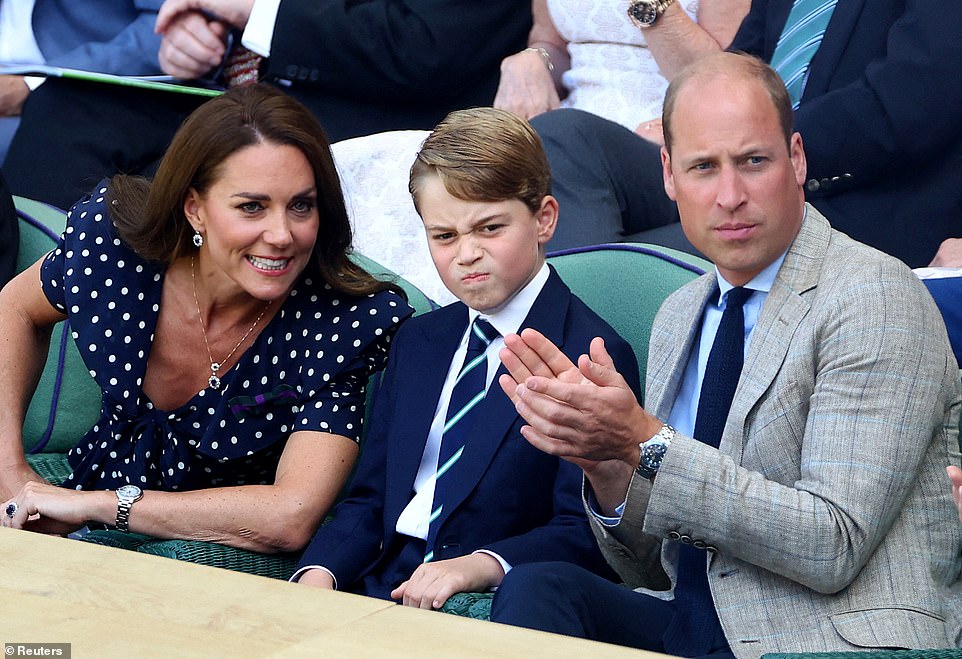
661, 52, 794, 153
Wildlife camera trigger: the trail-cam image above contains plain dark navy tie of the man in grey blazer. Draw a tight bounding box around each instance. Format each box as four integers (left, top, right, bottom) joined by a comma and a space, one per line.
663, 287, 754, 657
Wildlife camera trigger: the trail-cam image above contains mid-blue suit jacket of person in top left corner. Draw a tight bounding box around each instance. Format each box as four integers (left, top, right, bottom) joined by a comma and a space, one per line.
32, 0, 163, 75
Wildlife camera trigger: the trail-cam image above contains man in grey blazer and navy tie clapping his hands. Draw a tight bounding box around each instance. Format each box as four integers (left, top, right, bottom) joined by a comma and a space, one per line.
492, 53, 962, 659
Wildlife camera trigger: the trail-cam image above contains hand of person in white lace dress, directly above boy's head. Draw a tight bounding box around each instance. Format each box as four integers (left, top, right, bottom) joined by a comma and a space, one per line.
494, 50, 561, 119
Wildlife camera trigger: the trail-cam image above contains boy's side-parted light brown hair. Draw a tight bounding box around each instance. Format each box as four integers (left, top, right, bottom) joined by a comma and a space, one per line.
408, 108, 551, 213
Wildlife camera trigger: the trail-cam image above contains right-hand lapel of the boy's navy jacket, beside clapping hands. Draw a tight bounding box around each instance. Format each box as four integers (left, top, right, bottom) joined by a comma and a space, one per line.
439, 268, 571, 525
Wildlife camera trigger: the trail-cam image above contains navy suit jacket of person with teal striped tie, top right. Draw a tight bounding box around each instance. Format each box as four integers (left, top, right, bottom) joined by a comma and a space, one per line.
730, 0, 962, 267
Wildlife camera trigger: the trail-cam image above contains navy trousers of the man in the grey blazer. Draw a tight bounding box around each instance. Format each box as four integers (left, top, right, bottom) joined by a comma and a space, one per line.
491, 562, 734, 659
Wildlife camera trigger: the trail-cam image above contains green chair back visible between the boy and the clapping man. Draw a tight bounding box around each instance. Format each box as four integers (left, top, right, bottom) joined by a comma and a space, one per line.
548, 243, 712, 393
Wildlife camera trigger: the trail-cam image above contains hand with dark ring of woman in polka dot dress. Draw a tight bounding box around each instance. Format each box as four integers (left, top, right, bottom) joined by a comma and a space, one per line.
0, 481, 117, 535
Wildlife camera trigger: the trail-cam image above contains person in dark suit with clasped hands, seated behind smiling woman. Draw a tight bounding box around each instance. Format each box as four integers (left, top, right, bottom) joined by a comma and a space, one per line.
4, 0, 531, 207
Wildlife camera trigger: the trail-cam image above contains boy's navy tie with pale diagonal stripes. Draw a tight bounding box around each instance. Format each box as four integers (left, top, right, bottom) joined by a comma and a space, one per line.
424, 318, 499, 563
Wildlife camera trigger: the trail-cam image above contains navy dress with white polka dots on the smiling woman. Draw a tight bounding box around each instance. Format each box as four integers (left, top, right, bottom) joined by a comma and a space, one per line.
41, 185, 412, 491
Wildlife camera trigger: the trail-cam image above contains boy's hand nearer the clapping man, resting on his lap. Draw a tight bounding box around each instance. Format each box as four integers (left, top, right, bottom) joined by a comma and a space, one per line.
391, 552, 504, 609
